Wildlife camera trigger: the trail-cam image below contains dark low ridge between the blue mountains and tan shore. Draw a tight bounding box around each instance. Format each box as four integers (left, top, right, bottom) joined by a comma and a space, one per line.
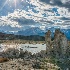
0, 32, 45, 41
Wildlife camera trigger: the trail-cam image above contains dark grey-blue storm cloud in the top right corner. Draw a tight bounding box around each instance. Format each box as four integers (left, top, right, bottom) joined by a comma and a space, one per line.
39, 0, 70, 9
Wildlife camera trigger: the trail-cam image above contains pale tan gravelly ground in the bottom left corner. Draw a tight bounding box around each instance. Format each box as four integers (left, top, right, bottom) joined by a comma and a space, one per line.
0, 59, 34, 70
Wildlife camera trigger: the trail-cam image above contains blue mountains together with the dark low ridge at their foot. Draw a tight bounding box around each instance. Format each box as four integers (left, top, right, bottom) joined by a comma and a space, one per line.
0, 27, 70, 40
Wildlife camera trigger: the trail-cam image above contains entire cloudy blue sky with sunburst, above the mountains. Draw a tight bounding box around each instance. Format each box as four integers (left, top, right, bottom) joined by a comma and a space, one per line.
0, 0, 70, 32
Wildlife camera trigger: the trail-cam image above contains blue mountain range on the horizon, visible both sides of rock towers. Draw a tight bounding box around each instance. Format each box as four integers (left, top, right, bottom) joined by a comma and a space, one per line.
0, 27, 70, 40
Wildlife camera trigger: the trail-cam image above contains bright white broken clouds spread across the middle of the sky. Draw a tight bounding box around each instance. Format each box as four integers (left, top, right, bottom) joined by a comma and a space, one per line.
0, 0, 70, 29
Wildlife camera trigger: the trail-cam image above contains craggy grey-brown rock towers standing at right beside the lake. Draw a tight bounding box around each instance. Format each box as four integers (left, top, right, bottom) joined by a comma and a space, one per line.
45, 29, 68, 58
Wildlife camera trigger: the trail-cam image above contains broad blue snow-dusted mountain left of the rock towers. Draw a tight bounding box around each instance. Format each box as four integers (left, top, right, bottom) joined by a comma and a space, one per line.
17, 27, 45, 36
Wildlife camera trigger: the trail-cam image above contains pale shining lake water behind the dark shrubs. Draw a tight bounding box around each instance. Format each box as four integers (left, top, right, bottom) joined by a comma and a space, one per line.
0, 44, 46, 54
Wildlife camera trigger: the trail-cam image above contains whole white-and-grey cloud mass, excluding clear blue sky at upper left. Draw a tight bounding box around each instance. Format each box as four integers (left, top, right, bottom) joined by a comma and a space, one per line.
0, 0, 70, 30
